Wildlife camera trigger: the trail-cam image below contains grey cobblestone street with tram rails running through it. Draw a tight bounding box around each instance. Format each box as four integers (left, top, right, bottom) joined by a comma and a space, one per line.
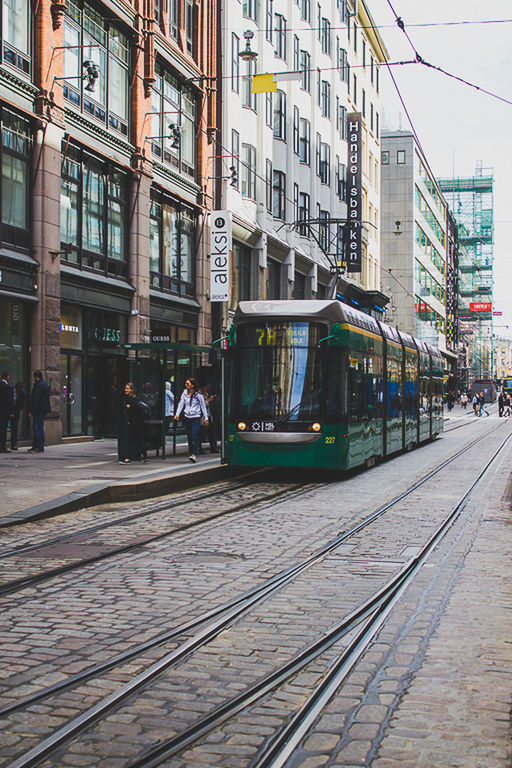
0, 417, 512, 768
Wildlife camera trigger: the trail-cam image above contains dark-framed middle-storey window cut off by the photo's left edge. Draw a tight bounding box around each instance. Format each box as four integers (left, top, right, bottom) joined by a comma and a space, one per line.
0, 109, 31, 248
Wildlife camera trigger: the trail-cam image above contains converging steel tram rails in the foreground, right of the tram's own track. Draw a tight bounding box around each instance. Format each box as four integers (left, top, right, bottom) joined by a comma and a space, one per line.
0, 425, 510, 768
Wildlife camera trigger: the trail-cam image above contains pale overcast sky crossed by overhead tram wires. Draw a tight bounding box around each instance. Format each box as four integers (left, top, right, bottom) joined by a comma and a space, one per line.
367, 0, 512, 338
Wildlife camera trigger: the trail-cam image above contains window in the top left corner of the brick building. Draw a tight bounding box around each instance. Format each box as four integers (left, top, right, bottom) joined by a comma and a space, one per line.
1, 0, 31, 75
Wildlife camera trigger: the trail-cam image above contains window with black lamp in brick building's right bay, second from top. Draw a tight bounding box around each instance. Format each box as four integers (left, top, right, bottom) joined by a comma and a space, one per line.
151, 67, 197, 178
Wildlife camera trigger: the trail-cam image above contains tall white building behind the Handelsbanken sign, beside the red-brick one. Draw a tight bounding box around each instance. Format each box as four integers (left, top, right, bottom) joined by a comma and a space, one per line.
216, 0, 388, 322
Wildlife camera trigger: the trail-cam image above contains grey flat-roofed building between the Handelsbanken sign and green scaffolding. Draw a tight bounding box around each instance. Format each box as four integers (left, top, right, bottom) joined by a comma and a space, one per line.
381, 131, 448, 370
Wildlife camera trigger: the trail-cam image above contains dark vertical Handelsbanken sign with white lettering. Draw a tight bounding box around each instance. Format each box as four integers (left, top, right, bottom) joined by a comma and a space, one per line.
346, 112, 363, 272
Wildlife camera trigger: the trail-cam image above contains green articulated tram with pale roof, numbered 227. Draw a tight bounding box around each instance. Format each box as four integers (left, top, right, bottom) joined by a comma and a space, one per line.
225, 300, 443, 470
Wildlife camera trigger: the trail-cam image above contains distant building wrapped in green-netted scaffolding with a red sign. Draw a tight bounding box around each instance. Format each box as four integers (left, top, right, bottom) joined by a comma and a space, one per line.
438, 163, 495, 388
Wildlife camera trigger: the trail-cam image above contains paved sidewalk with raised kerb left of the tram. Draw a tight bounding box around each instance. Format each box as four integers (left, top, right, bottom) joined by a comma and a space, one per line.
0, 439, 227, 526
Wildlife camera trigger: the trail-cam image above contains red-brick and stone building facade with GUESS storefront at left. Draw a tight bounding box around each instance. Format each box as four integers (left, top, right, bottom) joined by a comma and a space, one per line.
0, 0, 216, 442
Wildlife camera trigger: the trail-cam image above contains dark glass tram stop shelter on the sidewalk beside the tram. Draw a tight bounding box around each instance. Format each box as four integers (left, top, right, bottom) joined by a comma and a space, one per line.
124, 342, 220, 458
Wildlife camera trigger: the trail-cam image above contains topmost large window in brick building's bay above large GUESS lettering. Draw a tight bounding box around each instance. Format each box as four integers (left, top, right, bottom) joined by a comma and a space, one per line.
63, 2, 129, 136
